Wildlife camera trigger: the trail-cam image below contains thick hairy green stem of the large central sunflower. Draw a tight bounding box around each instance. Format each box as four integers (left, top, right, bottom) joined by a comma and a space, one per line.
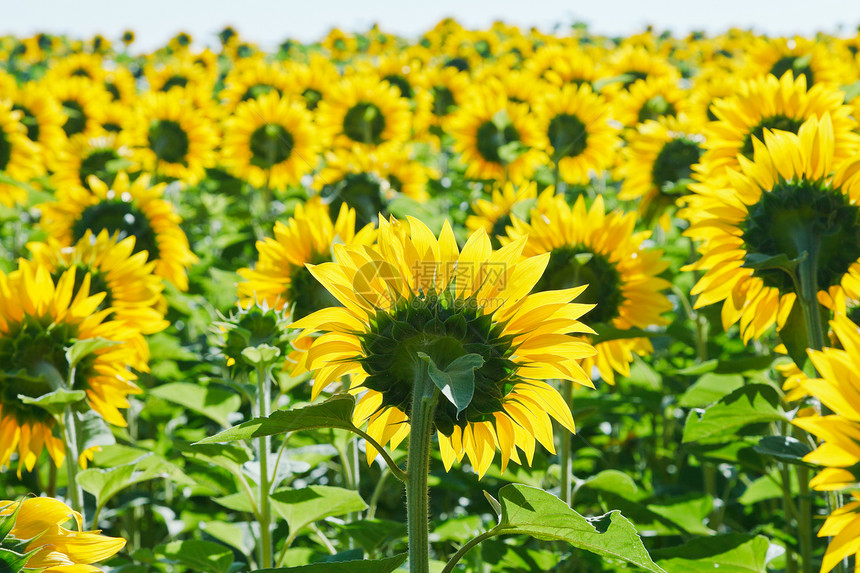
406, 363, 438, 573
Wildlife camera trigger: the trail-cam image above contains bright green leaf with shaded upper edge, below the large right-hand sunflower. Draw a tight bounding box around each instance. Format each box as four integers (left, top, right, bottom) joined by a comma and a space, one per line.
684, 384, 785, 443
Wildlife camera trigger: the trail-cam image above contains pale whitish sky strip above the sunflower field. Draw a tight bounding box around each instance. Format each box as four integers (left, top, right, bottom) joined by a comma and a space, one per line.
5, 0, 860, 50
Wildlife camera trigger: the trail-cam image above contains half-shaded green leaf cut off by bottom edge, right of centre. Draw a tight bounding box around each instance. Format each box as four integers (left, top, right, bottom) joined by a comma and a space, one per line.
652, 533, 770, 573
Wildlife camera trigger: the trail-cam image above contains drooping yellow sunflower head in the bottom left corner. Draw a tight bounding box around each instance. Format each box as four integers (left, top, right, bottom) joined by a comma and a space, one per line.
0, 497, 125, 573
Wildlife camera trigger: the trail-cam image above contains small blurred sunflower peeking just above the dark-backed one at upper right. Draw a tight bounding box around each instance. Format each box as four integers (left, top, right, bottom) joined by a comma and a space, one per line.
613, 77, 690, 127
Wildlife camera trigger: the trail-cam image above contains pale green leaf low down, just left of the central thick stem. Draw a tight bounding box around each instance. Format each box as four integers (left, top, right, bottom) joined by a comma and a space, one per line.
271, 485, 367, 533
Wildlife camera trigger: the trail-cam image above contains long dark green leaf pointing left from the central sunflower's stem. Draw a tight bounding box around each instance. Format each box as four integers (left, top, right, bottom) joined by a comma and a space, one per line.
197, 394, 355, 444
